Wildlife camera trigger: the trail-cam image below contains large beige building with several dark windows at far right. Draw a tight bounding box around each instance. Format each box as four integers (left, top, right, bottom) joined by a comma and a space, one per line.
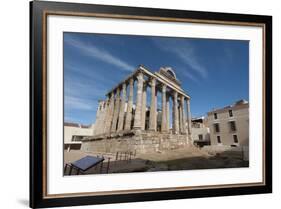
207, 100, 249, 146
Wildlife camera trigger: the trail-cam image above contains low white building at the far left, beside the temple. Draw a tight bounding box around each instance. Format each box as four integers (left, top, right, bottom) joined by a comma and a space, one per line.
64, 122, 94, 151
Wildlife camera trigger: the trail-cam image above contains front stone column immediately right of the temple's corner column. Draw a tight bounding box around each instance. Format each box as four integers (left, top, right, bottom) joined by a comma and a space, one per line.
149, 78, 157, 131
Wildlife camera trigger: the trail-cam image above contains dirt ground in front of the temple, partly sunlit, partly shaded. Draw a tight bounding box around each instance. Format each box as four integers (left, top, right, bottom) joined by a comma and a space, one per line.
64, 148, 249, 175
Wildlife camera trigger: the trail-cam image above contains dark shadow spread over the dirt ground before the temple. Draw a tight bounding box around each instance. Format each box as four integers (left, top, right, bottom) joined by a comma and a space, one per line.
65, 151, 249, 175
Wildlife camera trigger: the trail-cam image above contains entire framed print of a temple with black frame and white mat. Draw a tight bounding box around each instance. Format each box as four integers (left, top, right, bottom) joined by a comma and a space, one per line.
30, 1, 272, 208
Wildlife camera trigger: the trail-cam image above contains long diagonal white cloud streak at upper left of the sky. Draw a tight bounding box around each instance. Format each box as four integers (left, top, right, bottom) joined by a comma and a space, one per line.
65, 37, 134, 71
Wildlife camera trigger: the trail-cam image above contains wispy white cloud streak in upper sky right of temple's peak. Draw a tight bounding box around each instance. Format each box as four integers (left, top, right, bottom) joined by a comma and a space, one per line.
153, 39, 208, 78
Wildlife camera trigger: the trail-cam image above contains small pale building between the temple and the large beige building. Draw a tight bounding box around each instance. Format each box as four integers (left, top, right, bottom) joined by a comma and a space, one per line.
191, 117, 210, 147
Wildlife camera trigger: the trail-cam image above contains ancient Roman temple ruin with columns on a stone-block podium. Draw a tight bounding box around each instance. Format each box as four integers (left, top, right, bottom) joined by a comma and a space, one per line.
81, 65, 191, 153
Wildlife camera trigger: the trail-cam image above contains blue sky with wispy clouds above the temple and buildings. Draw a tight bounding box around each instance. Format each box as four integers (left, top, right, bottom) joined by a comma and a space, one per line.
63, 32, 249, 124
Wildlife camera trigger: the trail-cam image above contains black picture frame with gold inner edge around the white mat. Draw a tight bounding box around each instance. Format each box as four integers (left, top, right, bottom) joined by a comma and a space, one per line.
30, 1, 272, 208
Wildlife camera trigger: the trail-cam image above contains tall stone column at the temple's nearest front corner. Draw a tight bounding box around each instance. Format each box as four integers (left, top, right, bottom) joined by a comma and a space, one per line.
134, 72, 143, 129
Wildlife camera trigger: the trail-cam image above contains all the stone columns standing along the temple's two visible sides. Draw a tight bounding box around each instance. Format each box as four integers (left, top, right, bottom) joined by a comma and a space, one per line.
96, 72, 191, 134
